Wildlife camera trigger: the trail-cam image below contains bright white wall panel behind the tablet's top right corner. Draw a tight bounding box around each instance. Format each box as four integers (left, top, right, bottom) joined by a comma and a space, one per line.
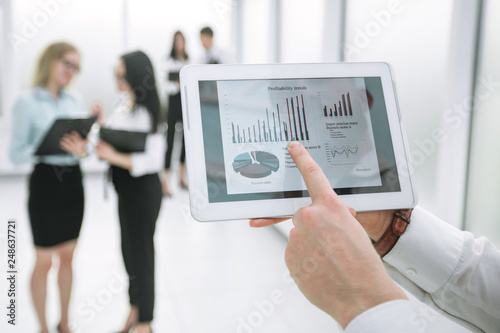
344, 0, 453, 220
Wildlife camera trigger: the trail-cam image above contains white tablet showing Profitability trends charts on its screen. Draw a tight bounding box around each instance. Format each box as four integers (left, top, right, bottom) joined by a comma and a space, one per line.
180, 63, 417, 221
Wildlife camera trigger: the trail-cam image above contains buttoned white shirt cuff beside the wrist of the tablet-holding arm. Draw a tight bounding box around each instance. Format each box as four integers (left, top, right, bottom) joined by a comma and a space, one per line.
384, 207, 464, 293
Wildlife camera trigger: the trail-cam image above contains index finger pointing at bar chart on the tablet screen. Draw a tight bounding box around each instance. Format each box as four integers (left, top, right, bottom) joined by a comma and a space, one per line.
287, 141, 334, 202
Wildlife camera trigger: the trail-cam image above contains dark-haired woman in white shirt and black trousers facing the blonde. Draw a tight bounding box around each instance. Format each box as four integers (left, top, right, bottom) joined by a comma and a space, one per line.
96, 51, 164, 333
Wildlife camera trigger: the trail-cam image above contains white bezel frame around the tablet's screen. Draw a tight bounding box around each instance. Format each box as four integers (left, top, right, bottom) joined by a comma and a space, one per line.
180, 63, 417, 222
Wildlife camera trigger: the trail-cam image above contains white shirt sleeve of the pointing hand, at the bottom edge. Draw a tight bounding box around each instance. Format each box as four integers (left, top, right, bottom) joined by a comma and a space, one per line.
345, 297, 470, 333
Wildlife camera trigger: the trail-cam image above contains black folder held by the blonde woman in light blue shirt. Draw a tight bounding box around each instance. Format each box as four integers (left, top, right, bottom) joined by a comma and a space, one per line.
35, 117, 97, 156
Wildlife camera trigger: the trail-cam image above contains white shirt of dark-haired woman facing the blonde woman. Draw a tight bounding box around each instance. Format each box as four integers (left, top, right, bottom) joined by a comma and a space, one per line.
104, 98, 165, 177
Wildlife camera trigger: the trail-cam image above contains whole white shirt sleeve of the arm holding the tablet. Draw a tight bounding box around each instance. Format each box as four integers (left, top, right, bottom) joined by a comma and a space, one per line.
384, 207, 500, 332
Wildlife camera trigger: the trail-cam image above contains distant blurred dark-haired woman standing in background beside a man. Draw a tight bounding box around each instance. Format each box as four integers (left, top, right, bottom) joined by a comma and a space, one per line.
162, 31, 188, 196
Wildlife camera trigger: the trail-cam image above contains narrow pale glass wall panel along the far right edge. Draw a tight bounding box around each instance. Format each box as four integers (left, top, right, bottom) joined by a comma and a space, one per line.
465, 1, 500, 247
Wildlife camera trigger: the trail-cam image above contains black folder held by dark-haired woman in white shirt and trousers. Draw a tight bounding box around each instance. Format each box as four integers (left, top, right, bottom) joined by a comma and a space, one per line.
100, 127, 148, 154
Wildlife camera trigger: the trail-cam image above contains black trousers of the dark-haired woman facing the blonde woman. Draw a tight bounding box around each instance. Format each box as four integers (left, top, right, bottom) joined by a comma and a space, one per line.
112, 166, 162, 322
